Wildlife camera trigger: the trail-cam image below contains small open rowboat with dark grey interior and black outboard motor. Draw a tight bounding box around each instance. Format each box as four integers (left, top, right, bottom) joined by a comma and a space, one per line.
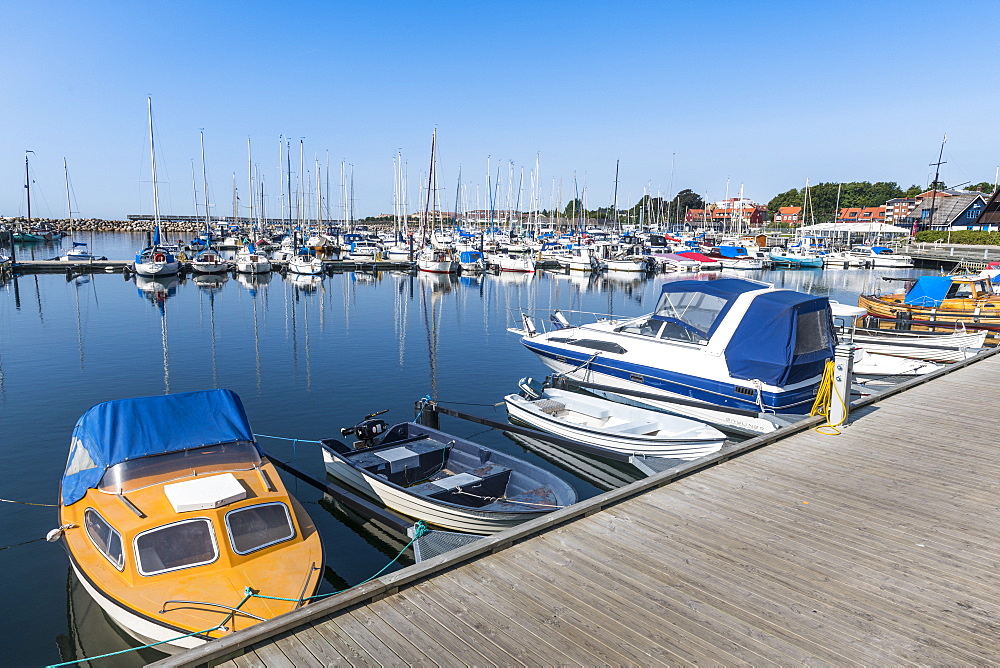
323, 416, 576, 534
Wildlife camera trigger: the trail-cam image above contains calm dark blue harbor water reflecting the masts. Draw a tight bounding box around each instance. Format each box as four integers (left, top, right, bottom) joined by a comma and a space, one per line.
0, 234, 936, 665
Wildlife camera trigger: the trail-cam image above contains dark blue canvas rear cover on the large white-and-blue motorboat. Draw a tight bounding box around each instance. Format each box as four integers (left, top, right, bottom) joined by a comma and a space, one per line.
728, 288, 837, 387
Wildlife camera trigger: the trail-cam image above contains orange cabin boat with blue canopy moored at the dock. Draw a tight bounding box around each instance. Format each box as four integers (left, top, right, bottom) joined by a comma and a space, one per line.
52, 390, 323, 651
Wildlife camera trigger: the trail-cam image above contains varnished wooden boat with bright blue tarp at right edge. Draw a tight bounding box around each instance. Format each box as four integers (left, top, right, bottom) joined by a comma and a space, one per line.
858, 276, 1000, 342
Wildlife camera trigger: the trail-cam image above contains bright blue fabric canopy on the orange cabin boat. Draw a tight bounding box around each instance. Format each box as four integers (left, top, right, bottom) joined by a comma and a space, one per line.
62, 390, 254, 506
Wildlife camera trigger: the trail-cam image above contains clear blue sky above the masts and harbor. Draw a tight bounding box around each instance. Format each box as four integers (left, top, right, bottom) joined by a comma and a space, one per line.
0, 0, 1000, 218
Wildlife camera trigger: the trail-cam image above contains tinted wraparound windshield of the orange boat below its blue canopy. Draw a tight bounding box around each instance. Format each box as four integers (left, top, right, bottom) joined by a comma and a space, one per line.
98, 441, 260, 494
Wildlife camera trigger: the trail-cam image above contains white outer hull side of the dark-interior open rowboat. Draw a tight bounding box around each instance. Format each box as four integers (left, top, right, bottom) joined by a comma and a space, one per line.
323, 448, 552, 534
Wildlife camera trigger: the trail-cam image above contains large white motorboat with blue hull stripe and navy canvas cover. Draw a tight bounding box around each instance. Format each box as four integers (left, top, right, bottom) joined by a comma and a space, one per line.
510, 278, 837, 432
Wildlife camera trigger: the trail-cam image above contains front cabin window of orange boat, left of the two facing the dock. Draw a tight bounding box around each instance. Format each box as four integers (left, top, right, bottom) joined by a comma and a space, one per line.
135, 518, 219, 575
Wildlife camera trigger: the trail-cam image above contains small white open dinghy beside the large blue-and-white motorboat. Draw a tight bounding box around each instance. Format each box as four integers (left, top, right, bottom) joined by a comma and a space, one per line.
504, 379, 726, 459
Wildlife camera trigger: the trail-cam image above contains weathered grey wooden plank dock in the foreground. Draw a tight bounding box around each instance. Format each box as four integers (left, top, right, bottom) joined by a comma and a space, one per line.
150, 350, 1000, 667
